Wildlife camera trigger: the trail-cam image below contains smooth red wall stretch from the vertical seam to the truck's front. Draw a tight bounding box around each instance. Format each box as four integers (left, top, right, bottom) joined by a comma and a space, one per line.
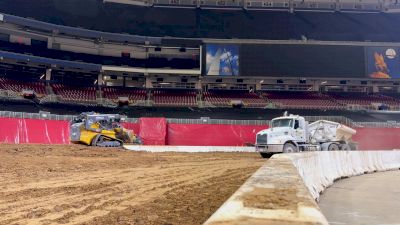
167, 124, 267, 146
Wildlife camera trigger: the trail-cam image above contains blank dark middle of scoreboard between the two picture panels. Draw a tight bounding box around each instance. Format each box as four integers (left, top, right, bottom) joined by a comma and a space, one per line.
240, 44, 365, 78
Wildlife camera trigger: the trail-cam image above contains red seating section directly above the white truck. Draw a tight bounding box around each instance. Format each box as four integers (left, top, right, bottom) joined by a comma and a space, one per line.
263, 91, 345, 109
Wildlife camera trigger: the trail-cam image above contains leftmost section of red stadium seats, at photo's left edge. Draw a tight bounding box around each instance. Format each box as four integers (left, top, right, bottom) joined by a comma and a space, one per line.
0, 78, 46, 97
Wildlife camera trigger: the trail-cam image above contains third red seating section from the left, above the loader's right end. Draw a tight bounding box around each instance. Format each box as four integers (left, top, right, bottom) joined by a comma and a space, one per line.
102, 87, 147, 103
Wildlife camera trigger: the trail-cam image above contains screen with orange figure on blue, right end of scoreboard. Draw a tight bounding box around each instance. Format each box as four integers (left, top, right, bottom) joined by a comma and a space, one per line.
366, 47, 400, 79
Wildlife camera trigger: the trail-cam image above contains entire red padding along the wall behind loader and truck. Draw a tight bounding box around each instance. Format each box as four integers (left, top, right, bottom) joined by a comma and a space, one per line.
0, 118, 400, 150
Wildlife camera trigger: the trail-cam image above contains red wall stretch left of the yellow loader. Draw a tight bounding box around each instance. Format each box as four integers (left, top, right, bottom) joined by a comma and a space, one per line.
0, 118, 69, 144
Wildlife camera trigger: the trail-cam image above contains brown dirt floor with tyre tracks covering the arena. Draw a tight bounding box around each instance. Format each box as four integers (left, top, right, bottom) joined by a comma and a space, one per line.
0, 144, 265, 225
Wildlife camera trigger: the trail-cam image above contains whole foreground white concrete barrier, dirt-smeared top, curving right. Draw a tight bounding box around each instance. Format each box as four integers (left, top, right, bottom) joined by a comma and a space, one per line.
204, 151, 400, 225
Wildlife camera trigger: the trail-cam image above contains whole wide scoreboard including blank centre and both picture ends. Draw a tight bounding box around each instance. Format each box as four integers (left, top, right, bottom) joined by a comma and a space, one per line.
203, 44, 400, 79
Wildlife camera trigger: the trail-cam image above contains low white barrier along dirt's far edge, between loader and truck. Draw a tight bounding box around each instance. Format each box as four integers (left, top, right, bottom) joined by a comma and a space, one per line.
124, 145, 255, 152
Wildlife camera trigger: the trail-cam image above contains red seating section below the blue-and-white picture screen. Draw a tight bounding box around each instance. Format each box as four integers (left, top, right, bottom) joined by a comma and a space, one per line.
203, 90, 267, 108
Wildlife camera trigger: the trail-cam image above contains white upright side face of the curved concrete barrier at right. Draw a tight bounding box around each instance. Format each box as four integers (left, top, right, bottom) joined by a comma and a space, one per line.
285, 151, 400, 200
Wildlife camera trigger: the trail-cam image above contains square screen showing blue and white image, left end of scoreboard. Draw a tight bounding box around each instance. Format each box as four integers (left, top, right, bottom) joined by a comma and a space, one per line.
206, 44, 239, 76
